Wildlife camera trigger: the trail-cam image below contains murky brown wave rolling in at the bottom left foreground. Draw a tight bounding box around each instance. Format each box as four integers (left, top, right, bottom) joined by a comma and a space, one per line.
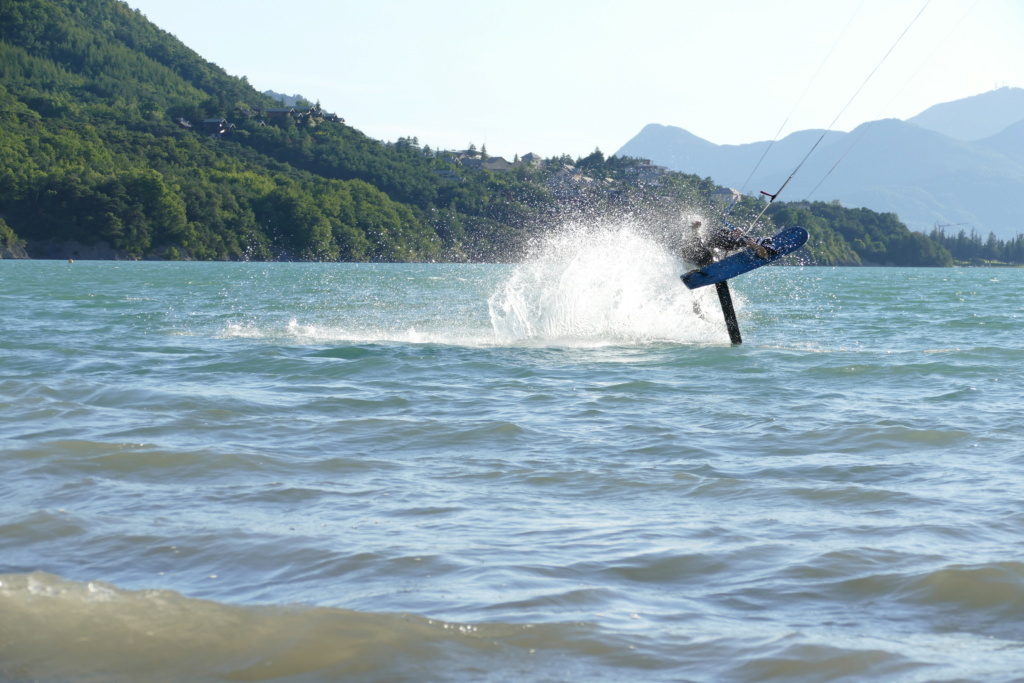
0, 572, 606, 683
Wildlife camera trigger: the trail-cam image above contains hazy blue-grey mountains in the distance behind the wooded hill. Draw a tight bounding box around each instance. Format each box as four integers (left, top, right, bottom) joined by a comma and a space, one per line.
616, 88, 1024, 240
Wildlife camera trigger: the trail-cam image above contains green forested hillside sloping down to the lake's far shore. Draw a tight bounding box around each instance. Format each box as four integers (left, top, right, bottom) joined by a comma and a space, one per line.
0, 0, 999, 266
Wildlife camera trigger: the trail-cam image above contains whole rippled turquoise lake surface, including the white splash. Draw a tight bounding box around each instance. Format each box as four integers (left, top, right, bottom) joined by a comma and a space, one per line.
0, 225, 1024, 683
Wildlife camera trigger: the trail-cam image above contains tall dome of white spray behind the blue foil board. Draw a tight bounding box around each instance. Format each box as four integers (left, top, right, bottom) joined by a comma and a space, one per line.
487, 221, 729, 346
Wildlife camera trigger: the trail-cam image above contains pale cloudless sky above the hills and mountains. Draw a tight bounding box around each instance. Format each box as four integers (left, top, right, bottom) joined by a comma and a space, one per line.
128, 0, 1024, 160
